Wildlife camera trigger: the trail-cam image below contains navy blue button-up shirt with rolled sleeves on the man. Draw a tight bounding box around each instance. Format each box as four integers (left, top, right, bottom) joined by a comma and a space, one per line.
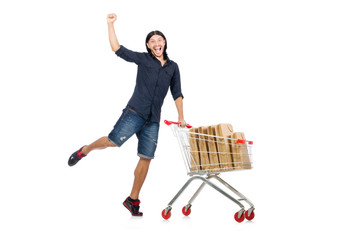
116, 46, 183, 123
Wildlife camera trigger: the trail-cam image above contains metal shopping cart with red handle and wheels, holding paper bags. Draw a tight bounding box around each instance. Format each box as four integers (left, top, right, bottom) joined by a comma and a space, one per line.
162, 120, 255, 222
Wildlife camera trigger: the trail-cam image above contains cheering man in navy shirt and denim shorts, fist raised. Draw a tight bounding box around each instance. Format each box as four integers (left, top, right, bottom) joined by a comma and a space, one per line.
68, 13, 186, 216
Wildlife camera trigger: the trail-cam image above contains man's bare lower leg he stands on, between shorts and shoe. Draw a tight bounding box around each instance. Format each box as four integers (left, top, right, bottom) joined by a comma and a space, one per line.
129, 158, 151, 199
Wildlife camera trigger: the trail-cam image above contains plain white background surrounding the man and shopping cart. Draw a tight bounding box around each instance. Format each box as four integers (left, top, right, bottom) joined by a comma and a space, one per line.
0, 0, 362, 239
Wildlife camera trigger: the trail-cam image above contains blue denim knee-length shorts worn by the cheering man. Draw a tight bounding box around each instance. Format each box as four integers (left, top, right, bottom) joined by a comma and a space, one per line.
108, 105, 160, 159
